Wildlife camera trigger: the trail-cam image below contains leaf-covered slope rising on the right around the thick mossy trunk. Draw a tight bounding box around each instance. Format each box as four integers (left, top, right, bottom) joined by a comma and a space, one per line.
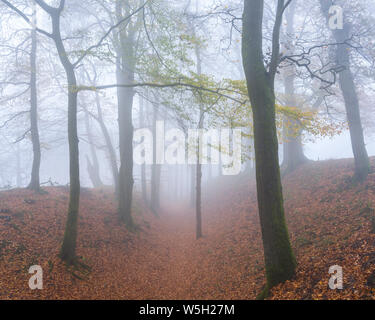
203, 159, 375, 299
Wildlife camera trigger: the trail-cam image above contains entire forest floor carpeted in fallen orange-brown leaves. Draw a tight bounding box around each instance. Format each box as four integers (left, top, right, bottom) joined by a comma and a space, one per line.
0, 159, 375, 300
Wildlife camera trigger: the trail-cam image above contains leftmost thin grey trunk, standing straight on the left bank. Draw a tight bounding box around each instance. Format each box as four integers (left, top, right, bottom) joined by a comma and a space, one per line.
28, 4, 41, 192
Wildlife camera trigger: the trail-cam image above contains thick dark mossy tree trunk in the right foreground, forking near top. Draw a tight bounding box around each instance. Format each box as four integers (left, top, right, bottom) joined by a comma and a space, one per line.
242, 0, 296, 294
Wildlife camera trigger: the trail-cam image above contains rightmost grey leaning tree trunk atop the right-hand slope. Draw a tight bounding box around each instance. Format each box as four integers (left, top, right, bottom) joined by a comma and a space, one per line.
320, 0, 370, 181
